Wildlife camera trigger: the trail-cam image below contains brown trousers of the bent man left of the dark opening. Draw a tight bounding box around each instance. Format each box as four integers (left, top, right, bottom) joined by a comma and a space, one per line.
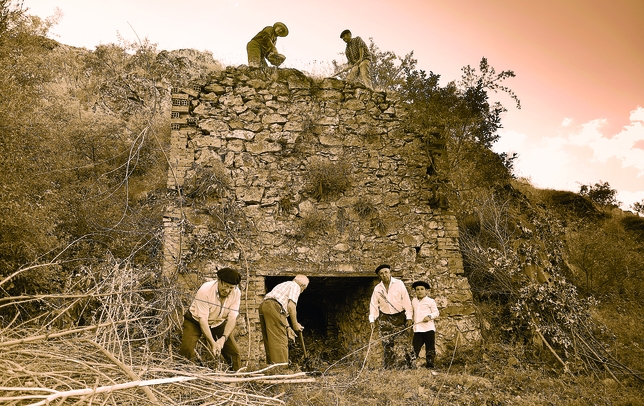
259, 299, 288, 364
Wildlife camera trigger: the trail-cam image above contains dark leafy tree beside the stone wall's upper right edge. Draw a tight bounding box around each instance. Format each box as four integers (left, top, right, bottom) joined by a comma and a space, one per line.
401, 58, 520, 213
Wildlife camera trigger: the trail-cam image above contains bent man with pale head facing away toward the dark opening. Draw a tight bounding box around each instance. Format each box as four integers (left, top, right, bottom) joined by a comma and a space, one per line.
259, 275, 309, 364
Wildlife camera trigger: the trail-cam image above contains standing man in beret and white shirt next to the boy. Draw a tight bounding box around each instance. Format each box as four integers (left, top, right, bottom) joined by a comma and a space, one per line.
369, 264, 414, 369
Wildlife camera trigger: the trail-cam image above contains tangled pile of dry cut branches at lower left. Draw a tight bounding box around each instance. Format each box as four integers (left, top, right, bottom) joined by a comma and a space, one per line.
0, 264, 314, 405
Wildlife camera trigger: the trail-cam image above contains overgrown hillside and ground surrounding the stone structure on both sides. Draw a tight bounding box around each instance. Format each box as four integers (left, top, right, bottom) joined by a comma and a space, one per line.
0, 3, 644, 405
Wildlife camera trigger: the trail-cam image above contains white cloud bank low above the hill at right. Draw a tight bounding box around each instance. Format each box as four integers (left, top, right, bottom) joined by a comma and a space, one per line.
494, 106, 644, 209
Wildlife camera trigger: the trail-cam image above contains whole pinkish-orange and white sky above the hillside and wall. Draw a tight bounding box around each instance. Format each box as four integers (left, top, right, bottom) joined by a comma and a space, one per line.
23, 0, 644, 209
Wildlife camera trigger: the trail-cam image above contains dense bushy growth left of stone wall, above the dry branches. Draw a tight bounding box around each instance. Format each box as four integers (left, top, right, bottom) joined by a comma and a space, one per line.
0, 1, 173, 292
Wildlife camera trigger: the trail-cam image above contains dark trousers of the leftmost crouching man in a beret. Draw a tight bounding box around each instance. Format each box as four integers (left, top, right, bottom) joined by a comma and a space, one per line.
179, 311, 241, 371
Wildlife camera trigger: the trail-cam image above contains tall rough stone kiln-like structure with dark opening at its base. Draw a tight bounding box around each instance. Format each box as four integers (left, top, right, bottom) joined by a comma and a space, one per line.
163, 66, 480, 362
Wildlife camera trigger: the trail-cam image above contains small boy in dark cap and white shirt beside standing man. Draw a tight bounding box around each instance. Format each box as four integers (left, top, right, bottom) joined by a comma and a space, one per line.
411, 281, 439, 368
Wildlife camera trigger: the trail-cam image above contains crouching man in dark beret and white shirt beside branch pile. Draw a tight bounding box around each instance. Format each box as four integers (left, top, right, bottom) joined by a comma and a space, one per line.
180, 268, 241, 371
